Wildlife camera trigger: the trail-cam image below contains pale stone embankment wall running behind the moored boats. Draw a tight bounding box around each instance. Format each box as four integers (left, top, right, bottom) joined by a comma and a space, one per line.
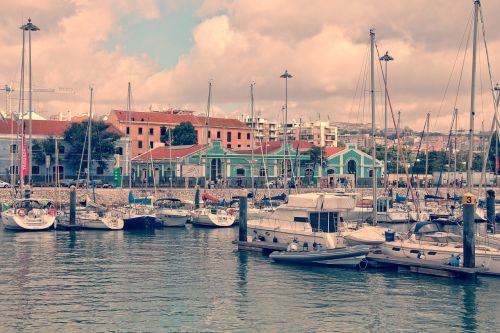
0, 187, 492, 206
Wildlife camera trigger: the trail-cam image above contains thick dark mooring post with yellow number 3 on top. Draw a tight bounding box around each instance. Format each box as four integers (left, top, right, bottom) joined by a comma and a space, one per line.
462, 193, 476, 268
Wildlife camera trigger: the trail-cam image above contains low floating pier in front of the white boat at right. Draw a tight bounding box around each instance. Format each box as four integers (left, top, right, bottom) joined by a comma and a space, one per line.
366, 252, 488, 279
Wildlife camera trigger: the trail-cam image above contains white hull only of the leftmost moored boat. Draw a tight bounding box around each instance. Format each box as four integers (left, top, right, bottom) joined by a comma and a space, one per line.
2, 209, 56, 231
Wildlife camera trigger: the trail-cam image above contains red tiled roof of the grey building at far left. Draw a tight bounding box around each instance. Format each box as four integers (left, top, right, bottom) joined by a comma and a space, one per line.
0, 119, 123, 137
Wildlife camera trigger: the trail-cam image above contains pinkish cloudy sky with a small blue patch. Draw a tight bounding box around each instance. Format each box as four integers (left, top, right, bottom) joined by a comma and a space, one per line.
0, 0, 500, 131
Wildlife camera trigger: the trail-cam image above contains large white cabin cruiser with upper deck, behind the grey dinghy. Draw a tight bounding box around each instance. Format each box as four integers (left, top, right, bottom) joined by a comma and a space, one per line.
247, 193, 355, 249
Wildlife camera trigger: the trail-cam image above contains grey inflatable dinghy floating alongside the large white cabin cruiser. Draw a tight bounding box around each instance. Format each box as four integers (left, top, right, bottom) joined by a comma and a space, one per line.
269, 245, 370, 268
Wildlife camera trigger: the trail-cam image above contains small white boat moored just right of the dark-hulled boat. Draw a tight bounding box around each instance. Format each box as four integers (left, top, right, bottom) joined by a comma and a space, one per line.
155, 198, 191, 227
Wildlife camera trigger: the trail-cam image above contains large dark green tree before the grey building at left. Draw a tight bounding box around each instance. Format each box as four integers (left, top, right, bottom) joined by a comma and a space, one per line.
64, 121, 120, 170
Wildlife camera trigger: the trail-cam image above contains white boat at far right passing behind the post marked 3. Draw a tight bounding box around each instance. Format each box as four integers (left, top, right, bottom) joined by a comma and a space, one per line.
380, 222, 500, 274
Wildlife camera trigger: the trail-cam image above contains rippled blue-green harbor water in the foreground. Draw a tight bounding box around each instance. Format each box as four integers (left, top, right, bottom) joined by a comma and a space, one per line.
0, 226, 500, 332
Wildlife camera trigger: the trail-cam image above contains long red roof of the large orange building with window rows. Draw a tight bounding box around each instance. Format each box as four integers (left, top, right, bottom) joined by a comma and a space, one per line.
111, 110, 249, 129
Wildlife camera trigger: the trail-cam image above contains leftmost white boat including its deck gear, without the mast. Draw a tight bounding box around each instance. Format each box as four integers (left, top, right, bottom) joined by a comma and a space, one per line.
2, 199, 57, 231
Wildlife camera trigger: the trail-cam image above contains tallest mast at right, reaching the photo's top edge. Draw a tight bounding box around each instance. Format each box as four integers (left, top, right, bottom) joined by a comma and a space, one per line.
467, 0, 480, 193
